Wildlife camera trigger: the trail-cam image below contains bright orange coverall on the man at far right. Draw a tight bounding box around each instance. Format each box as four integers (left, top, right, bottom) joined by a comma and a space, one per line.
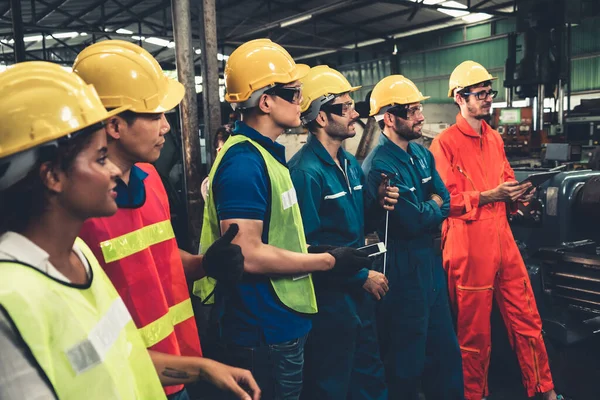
430, 113, 554, 400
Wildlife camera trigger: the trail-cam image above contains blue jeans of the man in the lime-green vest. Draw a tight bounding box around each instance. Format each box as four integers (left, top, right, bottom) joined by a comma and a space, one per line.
216, 335, 307, 400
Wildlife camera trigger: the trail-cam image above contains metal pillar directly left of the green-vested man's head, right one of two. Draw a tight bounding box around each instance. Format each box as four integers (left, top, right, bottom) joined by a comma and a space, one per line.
200, 0, 221, 168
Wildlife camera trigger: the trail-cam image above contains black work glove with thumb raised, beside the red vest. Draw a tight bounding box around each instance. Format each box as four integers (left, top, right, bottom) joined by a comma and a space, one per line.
202, 224, 244, 286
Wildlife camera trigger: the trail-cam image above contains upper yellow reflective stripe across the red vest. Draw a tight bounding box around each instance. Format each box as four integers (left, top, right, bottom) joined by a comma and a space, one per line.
100, 221, 175, 264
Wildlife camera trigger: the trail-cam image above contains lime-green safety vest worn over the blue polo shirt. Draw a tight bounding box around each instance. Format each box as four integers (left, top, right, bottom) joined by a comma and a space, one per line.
193, 135, 317, 314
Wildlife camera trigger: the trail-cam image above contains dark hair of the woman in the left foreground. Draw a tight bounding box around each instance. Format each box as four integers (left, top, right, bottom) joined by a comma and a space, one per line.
0, 130, 100, 234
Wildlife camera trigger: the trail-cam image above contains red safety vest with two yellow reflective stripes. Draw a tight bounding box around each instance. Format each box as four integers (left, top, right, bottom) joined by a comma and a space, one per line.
81, 163, 202, 395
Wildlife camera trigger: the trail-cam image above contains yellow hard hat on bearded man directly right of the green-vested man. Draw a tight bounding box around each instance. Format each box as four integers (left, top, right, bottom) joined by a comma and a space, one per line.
300, 65, 361, 124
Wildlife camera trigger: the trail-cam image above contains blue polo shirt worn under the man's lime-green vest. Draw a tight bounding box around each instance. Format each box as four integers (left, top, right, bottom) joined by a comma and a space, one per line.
212, 121, 311, 346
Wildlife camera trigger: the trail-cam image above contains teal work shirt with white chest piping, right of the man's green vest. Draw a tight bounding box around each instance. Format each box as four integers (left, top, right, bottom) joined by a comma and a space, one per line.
289, 134, 369, 290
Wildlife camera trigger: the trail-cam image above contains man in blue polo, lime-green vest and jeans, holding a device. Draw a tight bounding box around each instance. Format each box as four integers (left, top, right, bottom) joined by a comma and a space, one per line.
195, 39, 370, 400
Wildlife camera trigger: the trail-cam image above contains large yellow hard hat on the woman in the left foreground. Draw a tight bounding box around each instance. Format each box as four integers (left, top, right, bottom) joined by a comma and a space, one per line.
0, 61, 127, 158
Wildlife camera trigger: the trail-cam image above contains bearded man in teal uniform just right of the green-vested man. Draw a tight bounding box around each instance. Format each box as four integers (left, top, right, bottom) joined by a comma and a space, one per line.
289, 66, 398, 400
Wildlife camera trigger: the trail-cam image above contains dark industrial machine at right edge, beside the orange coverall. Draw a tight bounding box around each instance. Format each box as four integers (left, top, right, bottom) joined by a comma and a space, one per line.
509, 169, 600, 345
